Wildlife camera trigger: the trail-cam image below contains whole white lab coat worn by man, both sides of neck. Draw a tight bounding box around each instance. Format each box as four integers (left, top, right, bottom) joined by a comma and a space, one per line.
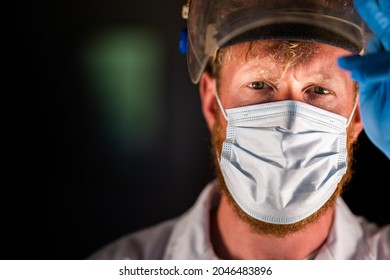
89, 181, 390, 260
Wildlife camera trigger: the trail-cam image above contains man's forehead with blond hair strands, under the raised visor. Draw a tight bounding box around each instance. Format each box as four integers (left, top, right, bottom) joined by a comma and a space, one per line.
215, 40, 351, 85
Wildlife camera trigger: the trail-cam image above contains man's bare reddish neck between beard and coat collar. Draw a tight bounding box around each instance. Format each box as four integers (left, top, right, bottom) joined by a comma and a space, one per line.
211, 194, 334, 260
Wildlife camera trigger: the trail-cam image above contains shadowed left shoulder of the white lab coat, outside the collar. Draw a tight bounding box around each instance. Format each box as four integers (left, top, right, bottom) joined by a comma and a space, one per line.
88, 219, 177, 260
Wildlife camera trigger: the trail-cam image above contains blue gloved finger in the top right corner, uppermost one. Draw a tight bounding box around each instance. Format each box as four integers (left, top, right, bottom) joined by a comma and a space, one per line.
354, 0, 390, 51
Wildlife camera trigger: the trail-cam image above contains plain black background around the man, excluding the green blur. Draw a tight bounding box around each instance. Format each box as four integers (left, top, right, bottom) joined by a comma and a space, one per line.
4, 0, 390, 259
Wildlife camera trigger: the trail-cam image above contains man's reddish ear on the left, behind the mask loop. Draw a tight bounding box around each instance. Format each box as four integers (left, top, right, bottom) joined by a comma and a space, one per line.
199, 72, 217, 131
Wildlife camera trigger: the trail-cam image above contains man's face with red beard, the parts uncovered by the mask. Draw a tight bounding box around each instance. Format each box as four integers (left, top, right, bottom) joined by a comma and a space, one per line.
206, 41, 361, 236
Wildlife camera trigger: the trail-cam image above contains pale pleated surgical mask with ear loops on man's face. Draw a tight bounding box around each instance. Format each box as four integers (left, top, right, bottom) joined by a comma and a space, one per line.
217, 96, 356, 224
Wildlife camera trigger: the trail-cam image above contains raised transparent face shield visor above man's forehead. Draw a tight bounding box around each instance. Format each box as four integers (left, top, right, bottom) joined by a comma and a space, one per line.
187, 0, 367, 83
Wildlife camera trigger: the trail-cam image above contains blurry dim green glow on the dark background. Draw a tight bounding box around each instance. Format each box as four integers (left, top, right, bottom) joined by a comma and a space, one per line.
85, 28, 164, 153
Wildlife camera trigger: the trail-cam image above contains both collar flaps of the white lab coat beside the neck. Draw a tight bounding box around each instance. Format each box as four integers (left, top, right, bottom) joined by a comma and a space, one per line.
164, 180, 374, 260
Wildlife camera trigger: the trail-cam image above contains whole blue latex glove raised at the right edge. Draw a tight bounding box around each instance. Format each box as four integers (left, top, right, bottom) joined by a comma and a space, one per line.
338, 0, 390, 159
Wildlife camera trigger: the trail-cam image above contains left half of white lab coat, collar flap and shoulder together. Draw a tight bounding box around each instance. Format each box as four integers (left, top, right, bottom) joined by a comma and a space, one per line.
88, 182, 219, 260
